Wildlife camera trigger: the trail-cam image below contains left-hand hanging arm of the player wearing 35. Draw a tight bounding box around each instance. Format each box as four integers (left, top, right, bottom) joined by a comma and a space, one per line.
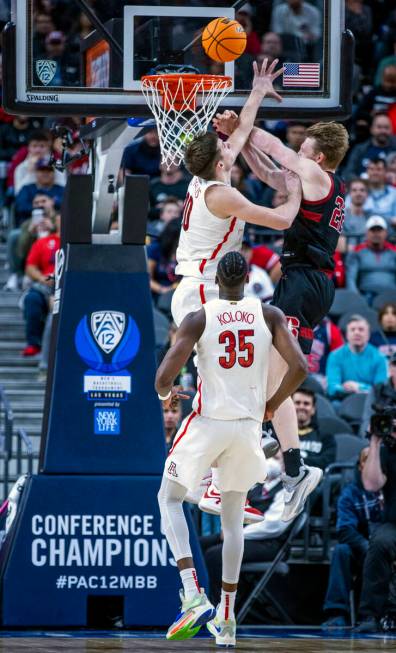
155, 309, 205, 398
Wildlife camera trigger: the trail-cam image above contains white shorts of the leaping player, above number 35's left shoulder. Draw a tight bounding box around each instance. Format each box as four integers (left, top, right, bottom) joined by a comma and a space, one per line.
171, 277, 219, 327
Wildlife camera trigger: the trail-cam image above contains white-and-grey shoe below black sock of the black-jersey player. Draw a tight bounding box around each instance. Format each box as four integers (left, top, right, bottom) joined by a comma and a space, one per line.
281, 465, 323, 521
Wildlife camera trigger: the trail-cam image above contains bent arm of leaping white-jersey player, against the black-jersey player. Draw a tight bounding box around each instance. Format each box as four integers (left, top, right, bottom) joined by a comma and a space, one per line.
205, 172, 301, 229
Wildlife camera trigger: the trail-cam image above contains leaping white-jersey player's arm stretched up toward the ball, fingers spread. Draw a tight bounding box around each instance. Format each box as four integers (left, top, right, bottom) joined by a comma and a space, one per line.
224, 59, 283, 158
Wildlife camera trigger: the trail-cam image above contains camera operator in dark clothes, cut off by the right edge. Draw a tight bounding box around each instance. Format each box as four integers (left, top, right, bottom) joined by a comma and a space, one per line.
357, 404, 396, 632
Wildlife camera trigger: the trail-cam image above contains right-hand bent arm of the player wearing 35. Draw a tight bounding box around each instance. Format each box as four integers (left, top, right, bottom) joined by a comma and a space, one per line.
263, 306, 308, 419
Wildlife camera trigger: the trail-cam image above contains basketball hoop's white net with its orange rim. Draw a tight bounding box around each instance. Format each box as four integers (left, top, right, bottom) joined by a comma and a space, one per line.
142, 73, 232, 168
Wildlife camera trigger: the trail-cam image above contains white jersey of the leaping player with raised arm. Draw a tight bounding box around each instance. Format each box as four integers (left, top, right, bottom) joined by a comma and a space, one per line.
176, 177, 245, 280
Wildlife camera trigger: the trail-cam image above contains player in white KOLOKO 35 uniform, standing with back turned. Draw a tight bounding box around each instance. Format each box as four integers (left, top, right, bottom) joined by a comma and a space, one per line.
155, 252, 307, 646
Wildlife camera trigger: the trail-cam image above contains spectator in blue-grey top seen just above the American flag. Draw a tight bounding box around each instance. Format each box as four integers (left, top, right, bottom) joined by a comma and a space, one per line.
271, 0, 322, 56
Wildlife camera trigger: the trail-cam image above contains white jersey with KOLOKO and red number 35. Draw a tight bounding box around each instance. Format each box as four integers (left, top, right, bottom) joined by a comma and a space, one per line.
193, 297, 272, 422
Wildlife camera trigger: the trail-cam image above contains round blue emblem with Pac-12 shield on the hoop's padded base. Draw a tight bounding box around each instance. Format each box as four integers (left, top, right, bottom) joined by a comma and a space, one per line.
74, 311, 140, 374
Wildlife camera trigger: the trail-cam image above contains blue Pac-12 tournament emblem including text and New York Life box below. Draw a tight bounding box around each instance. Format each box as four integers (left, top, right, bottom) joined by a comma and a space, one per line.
74, 310, 140, 435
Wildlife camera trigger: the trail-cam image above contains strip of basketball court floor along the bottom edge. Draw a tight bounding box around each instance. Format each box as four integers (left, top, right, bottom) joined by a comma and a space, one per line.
0, 627, 396, 653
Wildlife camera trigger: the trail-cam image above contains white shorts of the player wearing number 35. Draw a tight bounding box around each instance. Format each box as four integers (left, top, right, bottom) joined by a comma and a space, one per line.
164, 411, 267, 492
